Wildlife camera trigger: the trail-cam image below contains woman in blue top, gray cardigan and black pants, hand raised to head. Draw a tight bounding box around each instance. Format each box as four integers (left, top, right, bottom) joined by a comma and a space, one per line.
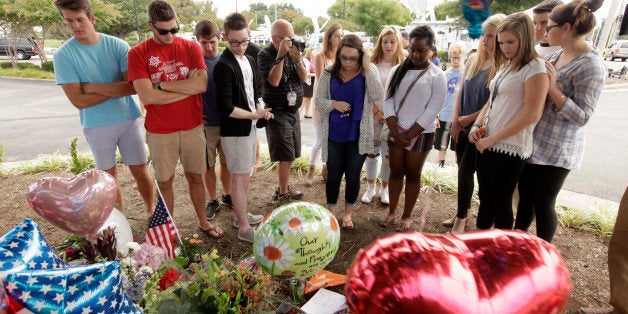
315, 35, 384, 229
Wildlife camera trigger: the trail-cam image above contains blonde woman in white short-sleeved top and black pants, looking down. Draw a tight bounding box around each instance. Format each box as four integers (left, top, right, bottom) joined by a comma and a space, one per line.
469, 12, 549, 229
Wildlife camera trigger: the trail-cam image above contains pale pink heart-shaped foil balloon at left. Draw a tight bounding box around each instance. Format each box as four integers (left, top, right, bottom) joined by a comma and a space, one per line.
27, 170, 117, 238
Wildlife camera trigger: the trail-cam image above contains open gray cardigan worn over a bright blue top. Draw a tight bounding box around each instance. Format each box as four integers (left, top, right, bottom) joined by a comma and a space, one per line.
314, 64, 384, 162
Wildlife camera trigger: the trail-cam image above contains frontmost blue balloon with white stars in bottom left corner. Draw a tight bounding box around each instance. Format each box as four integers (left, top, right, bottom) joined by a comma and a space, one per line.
4, 262, 142, 314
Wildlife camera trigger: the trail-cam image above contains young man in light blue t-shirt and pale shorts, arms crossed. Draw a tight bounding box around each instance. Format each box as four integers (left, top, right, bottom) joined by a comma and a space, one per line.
54, 0, 155, 214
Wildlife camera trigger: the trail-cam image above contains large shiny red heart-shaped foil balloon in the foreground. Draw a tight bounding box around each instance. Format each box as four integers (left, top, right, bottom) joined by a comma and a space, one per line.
345, 230, 571, 313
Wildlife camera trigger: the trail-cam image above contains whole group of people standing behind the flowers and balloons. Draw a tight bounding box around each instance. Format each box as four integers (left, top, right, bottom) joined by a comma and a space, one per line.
46, 0, 625, 310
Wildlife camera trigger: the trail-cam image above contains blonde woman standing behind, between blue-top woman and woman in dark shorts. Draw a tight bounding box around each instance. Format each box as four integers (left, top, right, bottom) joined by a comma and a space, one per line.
362, 26, 405, 205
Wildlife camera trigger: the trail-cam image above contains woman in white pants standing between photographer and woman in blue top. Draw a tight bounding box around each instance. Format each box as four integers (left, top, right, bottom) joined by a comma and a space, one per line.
306, 23, 343, 186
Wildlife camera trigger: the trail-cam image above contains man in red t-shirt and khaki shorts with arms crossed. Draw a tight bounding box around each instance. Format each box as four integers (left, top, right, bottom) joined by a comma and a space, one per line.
129, 0, 223, 238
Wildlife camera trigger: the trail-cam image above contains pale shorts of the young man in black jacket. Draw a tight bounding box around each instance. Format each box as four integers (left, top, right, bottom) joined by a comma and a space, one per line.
220, 127, 257, 174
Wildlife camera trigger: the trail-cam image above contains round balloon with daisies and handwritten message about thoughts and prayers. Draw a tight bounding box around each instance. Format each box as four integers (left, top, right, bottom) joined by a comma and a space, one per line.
253, 202, 340, 279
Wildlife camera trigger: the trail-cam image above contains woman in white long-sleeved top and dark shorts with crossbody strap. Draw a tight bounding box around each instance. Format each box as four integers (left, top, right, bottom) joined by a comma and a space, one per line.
380, 26, 447, 231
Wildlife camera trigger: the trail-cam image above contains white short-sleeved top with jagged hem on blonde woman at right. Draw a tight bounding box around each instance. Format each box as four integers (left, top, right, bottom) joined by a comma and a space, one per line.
483, 58, 546, 159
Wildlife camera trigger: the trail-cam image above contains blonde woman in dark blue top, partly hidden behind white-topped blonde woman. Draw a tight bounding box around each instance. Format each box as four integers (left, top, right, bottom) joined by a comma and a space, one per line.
443, 14, 506, 232
